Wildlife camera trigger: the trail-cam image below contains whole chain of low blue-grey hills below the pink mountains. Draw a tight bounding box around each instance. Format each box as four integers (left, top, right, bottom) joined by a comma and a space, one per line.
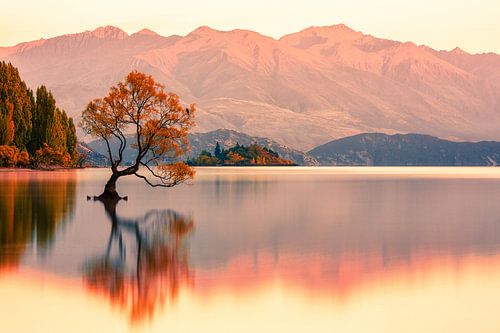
84, 129, 500, 166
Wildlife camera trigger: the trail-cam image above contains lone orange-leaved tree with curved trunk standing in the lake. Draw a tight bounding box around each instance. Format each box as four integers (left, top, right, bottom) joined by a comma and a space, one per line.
80, 71, 196, 201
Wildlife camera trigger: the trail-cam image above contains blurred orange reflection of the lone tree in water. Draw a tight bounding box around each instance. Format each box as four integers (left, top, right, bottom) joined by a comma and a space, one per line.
84, 198, 194, 322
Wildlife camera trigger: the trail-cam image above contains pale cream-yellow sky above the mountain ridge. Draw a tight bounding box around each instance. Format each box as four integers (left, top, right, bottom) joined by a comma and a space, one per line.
0, 0, 500, 53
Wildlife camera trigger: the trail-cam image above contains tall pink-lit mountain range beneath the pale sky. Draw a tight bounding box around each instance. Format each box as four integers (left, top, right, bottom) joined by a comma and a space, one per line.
0, 25, 500, 151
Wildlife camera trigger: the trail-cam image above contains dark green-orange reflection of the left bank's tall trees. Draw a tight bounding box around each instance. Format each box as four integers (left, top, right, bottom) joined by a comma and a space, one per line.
0, 173, 76, 268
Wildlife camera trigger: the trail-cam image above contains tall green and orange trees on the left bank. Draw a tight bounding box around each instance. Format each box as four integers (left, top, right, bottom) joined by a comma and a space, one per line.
0, 61, 78, 168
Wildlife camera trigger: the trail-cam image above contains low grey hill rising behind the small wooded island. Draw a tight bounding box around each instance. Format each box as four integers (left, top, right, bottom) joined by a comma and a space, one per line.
88, 129, 318, 165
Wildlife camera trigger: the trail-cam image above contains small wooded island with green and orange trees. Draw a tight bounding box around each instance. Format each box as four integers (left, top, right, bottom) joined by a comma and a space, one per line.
187, 142, 296, 166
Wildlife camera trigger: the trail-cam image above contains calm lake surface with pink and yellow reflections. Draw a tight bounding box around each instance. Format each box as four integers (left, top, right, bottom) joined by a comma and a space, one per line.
0, 168, 500, 333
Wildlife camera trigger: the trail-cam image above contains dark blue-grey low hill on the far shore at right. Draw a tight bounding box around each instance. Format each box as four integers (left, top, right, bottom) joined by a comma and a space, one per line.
308, 133, 500, 166
